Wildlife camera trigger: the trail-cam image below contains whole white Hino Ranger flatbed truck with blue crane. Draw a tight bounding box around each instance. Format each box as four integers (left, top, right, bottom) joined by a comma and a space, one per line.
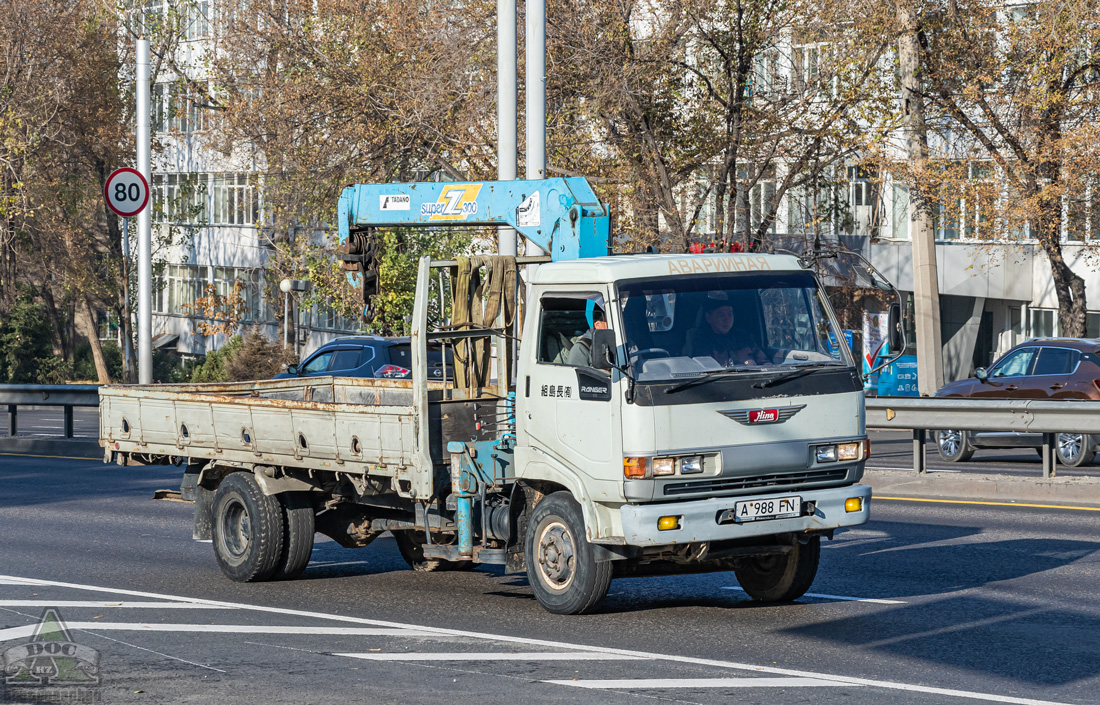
100, 178, 871, 614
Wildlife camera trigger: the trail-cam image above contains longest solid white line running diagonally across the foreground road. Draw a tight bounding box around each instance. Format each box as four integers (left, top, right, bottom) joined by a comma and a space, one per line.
0, 575, 1069, 705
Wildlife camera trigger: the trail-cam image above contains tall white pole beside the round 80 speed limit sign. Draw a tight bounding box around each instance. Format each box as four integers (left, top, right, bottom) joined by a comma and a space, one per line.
136, 38, 153, 384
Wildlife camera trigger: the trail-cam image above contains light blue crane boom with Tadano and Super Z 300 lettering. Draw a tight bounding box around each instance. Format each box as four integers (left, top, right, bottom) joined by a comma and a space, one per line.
338, 177, 611, 262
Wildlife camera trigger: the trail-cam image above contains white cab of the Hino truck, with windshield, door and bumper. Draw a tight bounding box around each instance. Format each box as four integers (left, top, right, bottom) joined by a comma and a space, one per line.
516, 254, 869, 611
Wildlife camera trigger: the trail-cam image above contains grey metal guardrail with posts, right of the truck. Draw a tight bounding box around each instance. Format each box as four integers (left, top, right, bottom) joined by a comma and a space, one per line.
867, 398, 1100, 477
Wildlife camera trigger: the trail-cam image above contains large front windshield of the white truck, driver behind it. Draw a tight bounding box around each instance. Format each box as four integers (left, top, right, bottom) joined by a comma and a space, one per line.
618, 272, 853, 382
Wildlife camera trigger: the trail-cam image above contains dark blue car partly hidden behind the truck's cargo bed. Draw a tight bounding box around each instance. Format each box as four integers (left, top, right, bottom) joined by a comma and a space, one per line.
275, 335, 451, 379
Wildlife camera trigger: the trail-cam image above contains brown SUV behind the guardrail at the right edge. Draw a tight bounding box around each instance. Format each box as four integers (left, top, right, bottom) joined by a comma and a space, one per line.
936, 338, 1100, 467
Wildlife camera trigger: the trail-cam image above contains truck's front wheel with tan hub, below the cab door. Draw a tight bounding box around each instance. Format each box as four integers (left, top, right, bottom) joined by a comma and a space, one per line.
525, 492, 612, 615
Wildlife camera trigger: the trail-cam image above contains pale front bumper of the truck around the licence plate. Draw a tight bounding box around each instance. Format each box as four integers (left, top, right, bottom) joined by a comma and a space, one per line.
620, 485, 871, 547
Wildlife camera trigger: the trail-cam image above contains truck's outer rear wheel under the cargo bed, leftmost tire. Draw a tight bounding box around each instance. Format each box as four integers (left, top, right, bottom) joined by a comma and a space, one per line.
212, 473, 286, 583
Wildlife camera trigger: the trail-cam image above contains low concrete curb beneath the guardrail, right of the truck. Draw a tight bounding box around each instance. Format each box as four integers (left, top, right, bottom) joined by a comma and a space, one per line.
862, 470, 1100, 507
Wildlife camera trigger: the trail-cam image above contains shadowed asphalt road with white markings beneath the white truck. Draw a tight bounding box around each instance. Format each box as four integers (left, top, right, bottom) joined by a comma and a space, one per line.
0, 455, 1100, 705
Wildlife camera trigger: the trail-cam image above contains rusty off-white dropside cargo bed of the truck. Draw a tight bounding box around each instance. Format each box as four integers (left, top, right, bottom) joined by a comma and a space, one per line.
100, 377, 472, 476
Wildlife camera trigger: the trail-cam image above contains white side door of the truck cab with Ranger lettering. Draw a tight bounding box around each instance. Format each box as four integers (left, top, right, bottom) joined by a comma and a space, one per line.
520, 290, 623, 499
